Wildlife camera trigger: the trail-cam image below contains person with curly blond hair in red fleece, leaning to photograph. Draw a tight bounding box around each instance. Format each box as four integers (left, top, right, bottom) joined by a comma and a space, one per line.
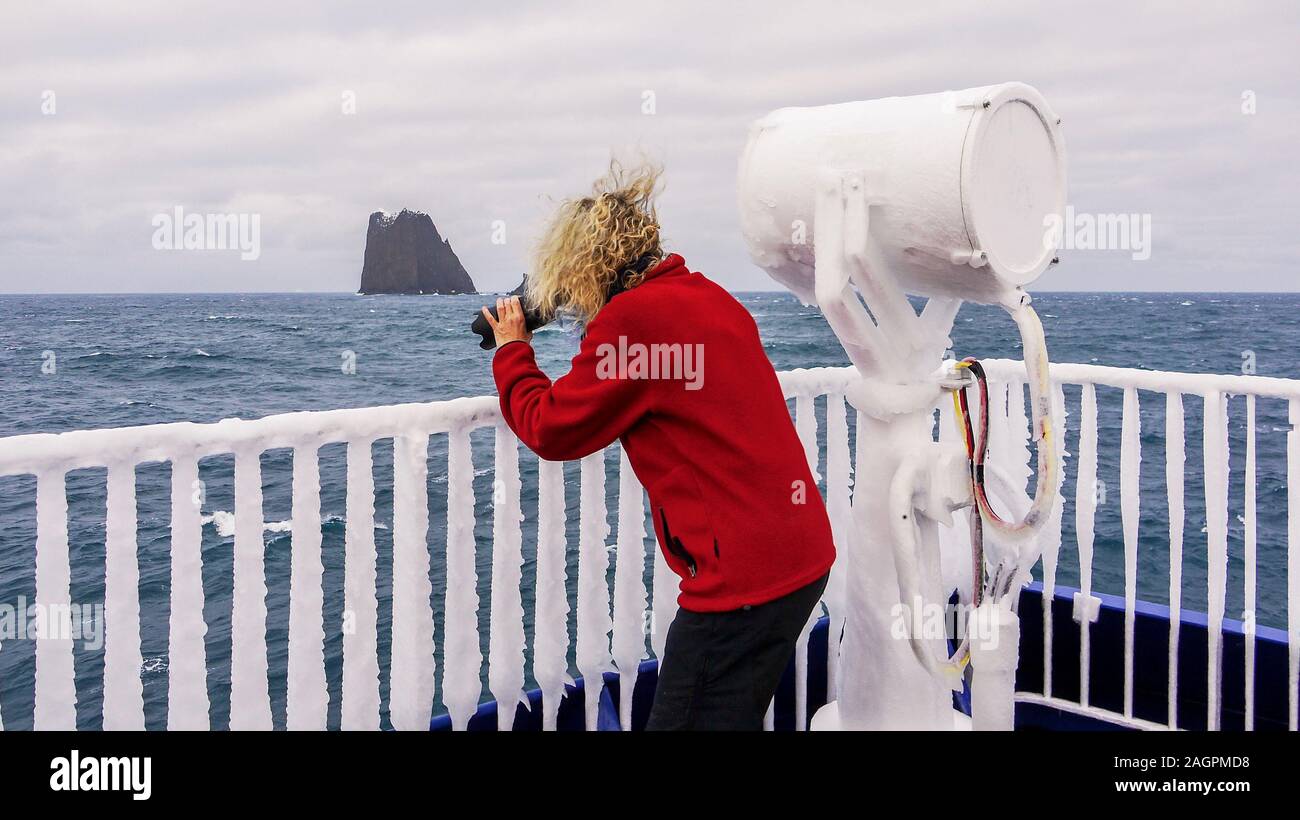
484, 164, 835, 729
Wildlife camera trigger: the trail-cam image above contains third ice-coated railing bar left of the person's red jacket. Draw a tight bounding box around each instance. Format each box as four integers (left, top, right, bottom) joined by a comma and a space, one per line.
577, 451, 612, 732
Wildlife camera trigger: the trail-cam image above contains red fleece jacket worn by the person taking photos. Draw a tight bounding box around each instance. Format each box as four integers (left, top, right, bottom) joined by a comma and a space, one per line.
493, 255, 835, 612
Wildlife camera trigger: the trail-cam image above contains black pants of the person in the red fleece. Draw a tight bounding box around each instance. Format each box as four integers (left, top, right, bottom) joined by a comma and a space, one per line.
646, 576, 828, 732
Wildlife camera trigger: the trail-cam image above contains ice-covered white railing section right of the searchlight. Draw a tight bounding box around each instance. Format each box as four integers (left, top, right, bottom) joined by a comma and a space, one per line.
985, 360, 1300, 730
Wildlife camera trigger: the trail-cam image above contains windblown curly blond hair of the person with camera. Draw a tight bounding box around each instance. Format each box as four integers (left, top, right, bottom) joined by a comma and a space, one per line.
525, 160, 663, 325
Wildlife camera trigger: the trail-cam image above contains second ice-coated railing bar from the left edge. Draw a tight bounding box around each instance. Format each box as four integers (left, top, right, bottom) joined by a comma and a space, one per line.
104, 464, 144, 732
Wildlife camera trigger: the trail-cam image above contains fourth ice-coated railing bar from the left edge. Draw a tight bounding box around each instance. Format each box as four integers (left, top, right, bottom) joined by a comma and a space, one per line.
230, 448, 272, 732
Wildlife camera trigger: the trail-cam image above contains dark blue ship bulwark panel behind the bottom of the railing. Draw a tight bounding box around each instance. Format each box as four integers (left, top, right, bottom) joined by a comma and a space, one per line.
430, 583, 1288, 732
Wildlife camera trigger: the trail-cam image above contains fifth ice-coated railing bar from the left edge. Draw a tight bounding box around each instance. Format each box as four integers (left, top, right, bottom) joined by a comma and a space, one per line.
286, 446, 329, 730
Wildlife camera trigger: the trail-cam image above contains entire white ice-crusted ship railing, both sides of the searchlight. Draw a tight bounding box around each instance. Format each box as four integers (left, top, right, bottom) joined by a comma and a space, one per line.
0, 361, 1300, 729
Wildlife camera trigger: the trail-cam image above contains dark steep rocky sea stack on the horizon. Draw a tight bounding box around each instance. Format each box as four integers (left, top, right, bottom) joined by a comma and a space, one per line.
360, 209, 477, 294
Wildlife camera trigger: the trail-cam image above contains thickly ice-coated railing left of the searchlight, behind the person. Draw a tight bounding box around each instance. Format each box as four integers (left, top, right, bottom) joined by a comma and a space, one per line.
0, 370, 848, 729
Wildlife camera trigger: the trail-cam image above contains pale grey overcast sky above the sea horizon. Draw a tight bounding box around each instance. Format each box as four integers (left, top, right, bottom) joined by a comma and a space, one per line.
0, 0, 1300, 292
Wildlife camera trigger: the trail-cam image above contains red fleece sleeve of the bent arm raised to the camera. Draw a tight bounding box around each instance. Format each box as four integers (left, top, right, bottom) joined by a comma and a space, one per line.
493, 315, 653, 461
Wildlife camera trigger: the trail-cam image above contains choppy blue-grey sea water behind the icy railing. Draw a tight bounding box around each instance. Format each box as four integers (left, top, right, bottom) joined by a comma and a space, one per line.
0, 292, 1300, 729
